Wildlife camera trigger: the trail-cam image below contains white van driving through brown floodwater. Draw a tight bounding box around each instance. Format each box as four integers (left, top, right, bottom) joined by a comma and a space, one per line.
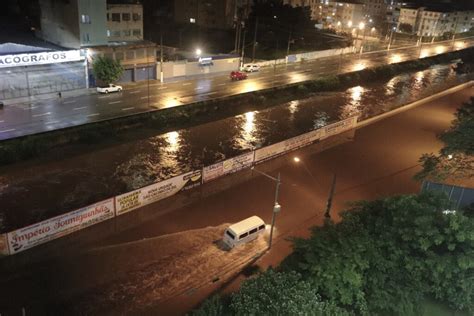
223, 216, 265, 248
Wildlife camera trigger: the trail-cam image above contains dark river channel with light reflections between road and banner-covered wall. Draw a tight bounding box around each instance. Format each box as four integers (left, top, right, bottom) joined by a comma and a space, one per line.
0, 65, 474, 232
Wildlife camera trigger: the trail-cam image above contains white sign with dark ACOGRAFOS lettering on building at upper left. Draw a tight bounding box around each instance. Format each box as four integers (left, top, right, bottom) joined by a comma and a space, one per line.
0, 50, 84, 68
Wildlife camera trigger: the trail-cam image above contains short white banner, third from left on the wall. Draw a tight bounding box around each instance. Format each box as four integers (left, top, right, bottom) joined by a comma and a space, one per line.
202, 151, 254, 183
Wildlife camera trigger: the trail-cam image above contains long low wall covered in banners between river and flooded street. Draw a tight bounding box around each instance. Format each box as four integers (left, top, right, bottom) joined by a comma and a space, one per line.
0, 117, 357, 256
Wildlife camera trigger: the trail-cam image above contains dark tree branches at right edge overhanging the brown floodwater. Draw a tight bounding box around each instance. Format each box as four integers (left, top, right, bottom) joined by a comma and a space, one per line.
415, 97, 474, 181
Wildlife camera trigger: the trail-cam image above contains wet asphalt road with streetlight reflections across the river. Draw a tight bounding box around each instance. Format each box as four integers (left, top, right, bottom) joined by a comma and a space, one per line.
0, 39, 474, 140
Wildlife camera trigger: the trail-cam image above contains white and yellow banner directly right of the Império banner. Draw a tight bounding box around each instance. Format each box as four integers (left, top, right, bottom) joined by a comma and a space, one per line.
115, 170, 201, 215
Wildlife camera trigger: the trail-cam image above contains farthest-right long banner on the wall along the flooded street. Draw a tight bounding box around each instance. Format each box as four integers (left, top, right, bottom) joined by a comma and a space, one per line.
255, 129, 324, 163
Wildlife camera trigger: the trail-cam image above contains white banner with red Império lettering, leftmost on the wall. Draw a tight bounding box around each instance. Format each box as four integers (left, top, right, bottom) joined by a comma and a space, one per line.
7, 198, 114, 254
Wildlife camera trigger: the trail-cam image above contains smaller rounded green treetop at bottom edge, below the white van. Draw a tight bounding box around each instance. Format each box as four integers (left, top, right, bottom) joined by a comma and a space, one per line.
230, 270, 349, 316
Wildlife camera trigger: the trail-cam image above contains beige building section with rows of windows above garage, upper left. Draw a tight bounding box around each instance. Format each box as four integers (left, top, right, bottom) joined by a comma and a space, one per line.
107, 4, 143, 42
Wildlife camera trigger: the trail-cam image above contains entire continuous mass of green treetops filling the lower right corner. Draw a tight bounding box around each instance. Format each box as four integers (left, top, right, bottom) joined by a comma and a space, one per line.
193, 192, 474, 316
